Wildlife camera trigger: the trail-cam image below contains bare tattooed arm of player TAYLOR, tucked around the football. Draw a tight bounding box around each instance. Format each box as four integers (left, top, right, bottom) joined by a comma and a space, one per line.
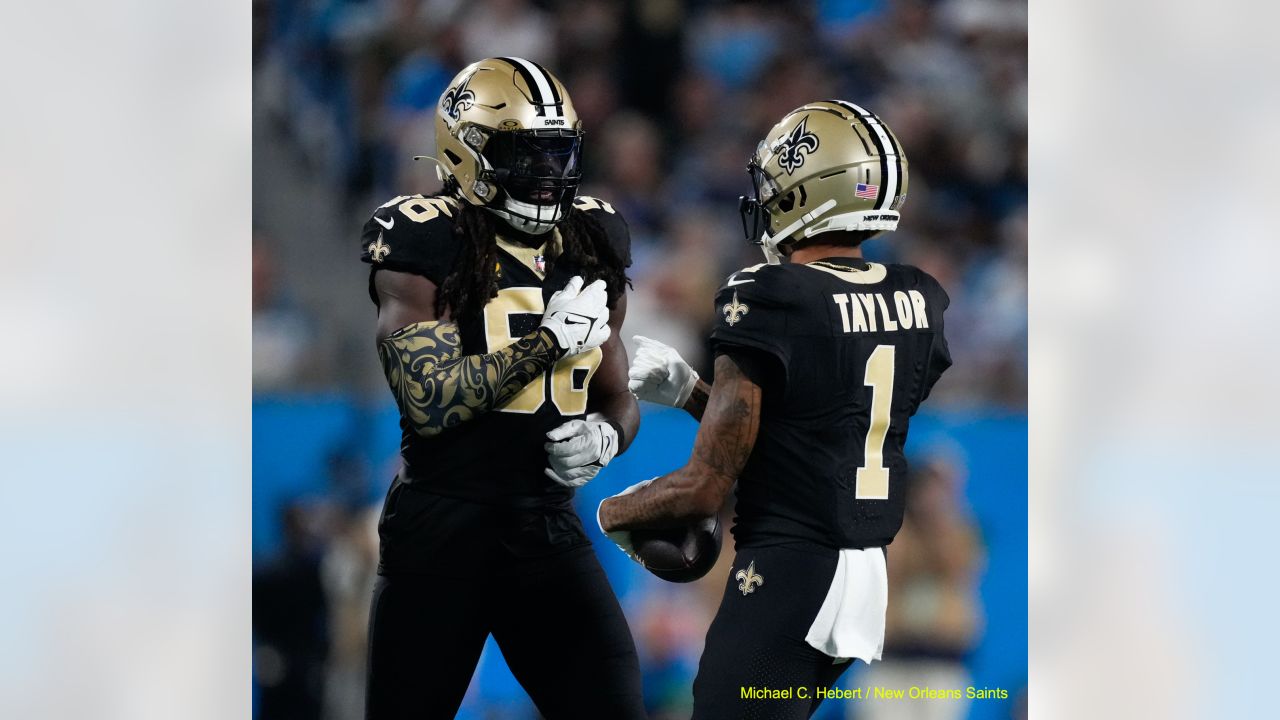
599, 355, 760, 532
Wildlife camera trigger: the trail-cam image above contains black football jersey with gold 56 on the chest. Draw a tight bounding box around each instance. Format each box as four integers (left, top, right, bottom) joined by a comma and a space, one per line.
361, 195, 630, 502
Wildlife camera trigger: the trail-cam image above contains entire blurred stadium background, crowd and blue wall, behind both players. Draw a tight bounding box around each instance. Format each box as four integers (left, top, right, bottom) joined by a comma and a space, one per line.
252, 0, 1027, 720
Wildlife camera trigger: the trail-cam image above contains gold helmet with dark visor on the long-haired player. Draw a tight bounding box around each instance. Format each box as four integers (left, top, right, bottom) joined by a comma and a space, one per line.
435, 58, 582, 234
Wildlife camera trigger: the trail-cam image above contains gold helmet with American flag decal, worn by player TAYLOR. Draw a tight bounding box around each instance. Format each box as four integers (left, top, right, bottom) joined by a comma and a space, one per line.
739, 100, 906, 263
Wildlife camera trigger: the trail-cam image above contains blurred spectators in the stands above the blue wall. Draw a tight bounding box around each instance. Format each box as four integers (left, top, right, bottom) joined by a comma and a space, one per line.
253, 0, 1027, 409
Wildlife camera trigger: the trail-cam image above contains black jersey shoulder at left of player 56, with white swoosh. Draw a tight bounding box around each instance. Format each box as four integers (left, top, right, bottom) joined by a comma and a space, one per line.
360, 195, 458, 284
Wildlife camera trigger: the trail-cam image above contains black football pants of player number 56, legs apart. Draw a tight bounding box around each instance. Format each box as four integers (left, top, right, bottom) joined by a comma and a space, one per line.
366, 546, 644, 720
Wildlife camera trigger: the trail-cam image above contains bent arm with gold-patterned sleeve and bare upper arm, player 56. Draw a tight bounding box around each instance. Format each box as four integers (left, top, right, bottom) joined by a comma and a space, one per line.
374, 270, 563, 437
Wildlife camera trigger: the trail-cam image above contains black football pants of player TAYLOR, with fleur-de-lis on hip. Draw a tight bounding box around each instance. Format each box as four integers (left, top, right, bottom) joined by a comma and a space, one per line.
694, 546, 852, 720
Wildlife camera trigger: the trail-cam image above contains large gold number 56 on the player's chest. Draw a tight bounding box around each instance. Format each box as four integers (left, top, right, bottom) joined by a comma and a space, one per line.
484, 287, 604, 415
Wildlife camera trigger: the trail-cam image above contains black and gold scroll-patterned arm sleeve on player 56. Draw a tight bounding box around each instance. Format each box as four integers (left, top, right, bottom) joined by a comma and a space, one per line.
378, 322, 562, 437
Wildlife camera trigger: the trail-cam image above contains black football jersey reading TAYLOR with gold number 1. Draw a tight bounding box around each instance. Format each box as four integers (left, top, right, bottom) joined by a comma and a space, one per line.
712, 258, 951, 548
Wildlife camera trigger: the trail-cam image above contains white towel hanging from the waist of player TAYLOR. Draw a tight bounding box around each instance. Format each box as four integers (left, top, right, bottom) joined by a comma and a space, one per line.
804, 547, 888, 662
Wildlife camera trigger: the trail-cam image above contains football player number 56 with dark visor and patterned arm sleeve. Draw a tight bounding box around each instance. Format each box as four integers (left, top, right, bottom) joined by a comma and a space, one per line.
361, 58, 644, 720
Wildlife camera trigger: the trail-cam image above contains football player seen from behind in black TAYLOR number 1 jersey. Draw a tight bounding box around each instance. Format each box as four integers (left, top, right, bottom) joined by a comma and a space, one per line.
598, 100, 951, 720
